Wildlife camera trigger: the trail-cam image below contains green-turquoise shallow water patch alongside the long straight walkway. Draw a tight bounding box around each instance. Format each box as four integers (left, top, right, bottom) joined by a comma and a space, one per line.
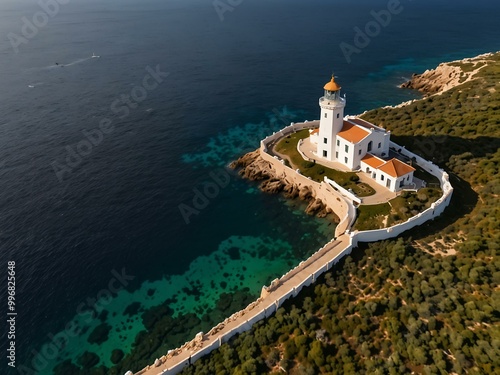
37, 236, 324, 366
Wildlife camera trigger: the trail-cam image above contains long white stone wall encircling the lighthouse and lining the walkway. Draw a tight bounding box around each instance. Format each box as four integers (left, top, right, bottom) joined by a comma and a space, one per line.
135, 125, 453, 375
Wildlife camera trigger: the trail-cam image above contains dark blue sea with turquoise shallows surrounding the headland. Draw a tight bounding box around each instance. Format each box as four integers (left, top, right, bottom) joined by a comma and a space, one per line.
0, 0, 500, 375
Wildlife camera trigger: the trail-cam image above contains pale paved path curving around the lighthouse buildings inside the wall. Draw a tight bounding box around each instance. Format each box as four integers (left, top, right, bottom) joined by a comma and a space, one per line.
299, 138, 398, 205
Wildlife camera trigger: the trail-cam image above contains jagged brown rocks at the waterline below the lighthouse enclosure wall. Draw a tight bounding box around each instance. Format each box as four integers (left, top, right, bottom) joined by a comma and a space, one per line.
229, 149, 340, 223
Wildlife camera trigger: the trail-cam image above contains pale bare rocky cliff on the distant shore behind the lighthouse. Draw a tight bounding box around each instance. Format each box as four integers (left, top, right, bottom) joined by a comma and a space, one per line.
400, 53, 493, 96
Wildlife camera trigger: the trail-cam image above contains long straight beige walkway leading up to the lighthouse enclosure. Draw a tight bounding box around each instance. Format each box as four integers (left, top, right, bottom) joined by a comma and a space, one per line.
136, 234, 350, 375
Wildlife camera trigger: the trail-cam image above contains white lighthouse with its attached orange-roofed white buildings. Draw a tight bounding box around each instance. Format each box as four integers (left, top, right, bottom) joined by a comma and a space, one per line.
310, 76, 415, 191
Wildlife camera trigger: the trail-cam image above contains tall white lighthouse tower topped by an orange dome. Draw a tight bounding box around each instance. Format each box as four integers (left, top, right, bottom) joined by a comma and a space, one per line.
317, 75, 345, 161
